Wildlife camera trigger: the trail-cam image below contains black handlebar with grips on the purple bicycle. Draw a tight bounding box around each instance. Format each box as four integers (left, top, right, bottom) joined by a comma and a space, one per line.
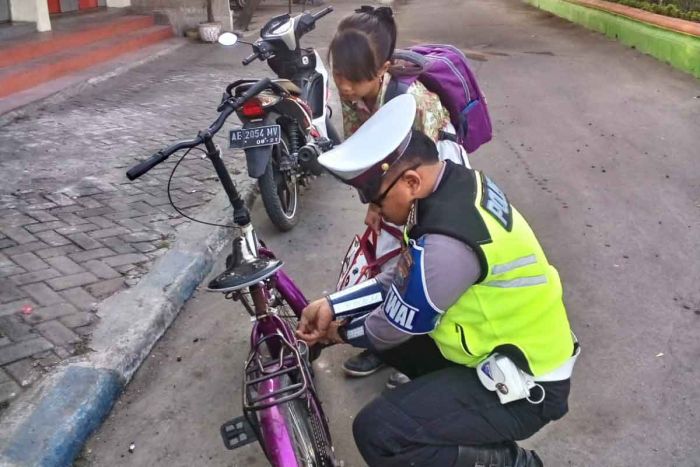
126, 78, 271, 180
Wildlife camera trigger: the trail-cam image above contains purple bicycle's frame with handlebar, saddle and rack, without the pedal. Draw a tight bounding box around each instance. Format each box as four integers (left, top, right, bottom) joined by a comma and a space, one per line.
127, 79, 334, 467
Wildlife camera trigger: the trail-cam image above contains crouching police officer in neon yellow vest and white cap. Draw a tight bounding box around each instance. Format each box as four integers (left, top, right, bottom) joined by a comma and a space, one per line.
298, 96, 578, 467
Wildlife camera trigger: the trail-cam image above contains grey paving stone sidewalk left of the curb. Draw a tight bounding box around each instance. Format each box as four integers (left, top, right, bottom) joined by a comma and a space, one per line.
0, 44, 264, 412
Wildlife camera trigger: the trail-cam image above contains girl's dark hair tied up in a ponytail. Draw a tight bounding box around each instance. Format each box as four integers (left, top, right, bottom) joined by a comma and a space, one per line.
328, 6, 396, 82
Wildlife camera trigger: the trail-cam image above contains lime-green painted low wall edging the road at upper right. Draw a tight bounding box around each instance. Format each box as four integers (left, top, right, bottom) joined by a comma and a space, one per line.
525, 0, 700, 78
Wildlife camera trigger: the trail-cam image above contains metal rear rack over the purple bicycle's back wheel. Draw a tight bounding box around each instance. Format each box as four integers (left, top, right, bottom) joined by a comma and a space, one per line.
243, 333, 309, 412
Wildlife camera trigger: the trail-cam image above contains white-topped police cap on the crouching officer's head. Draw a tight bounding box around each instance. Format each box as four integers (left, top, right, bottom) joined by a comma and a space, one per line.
318, 94, 416, 189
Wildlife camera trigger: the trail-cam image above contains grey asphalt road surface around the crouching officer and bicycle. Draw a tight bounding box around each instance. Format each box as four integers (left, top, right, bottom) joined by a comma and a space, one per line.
81, 0, 700, 467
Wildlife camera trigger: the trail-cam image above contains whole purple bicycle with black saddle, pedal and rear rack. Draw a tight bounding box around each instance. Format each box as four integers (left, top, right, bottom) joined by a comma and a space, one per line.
127, 78, 341, 467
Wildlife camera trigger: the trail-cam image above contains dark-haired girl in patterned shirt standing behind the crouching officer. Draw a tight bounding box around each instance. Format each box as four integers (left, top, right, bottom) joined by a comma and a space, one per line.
328, 6, 469, 386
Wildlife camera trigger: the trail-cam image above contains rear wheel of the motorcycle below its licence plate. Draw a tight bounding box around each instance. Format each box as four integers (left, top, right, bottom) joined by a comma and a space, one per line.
258, 135, 299, 232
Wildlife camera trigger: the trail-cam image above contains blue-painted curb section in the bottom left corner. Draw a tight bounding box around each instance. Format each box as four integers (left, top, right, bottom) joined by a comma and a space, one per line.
0, 366, 124, 467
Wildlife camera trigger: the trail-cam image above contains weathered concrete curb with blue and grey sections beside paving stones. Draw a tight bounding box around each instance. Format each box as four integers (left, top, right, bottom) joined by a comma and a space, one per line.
0, 181, 256, 467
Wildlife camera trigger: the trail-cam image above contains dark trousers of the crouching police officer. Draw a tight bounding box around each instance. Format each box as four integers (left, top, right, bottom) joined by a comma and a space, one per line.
353, 336, 569, 467
